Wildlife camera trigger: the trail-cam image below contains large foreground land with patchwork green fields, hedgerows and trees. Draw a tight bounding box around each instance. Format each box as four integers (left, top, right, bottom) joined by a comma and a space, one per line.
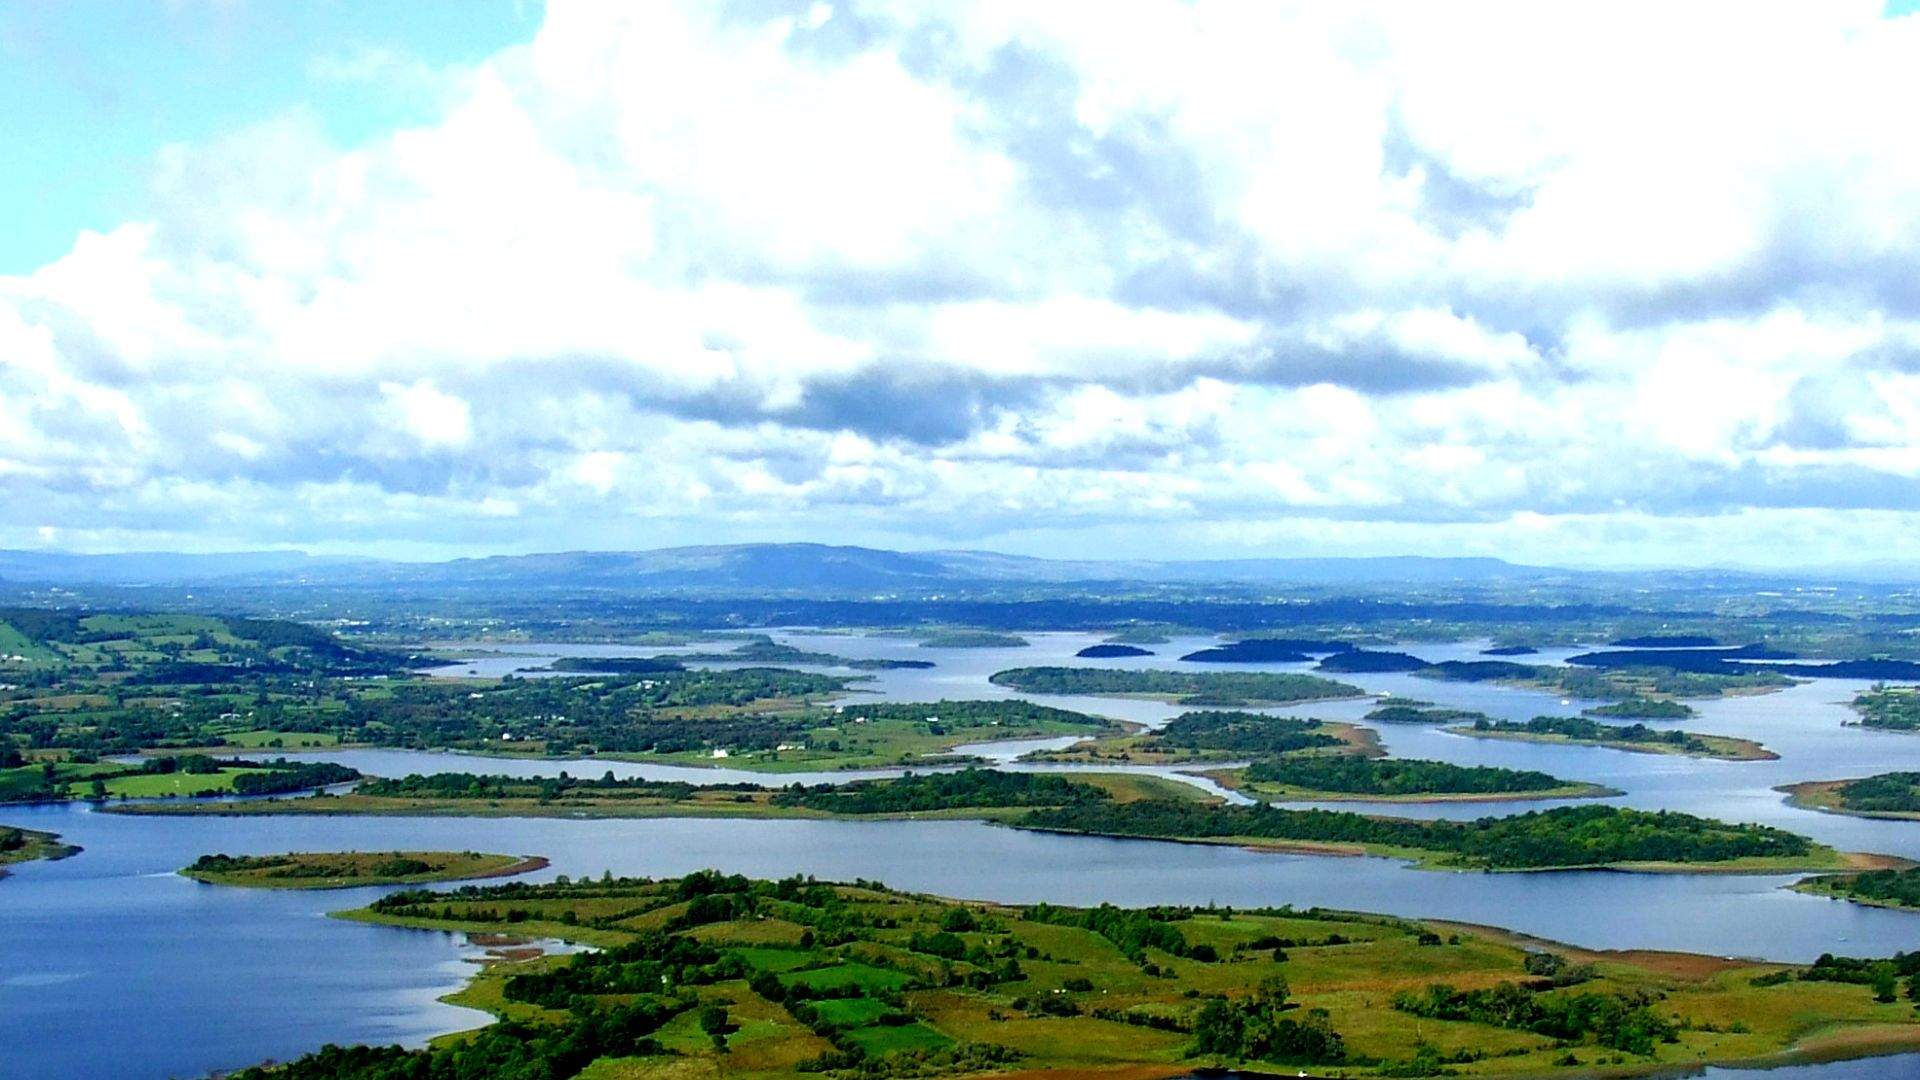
224, 871, 1920, 1080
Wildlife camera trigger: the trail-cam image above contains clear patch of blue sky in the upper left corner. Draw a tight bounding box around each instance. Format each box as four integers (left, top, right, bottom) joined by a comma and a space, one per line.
0, 0, 541, 273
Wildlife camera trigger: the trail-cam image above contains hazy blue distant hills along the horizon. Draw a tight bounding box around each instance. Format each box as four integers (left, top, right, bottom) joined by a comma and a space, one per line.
0, 544, 1914, 596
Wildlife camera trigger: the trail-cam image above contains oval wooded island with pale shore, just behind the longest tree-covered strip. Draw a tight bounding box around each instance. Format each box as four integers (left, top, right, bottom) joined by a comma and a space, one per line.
1208, 755, 1620, 803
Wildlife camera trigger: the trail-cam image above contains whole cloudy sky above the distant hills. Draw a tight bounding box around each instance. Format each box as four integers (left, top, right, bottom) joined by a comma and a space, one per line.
0, 0, 1920, 567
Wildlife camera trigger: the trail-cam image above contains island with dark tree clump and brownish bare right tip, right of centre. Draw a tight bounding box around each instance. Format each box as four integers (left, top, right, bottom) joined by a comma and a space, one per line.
1021, 709, 1382, 765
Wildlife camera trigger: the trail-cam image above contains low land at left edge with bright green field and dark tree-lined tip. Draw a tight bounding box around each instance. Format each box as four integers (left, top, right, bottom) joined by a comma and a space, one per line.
0, 753, 359, 803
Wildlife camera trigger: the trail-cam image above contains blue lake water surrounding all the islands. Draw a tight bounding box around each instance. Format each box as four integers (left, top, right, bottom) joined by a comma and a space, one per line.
0, 632, 1920, 1080
